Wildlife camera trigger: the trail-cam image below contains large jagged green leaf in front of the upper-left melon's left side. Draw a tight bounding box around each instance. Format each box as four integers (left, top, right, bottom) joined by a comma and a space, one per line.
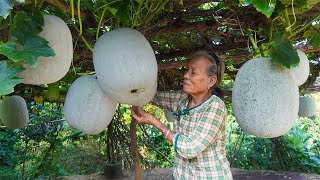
0, 29, 55, 67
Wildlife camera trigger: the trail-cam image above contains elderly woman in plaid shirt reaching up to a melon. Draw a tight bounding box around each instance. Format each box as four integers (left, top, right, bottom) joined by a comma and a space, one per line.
132, 51, 232, 180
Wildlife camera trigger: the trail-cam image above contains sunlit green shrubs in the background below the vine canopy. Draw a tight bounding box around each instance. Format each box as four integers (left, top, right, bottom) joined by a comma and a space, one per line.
0, 93, 320, 179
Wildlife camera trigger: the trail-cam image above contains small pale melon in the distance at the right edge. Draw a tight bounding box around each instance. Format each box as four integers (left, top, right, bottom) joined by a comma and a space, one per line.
298, 96, 317, 117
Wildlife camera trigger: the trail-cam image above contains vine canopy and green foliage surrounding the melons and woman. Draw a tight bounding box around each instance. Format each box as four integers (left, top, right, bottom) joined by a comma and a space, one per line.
0, 0, 320, 179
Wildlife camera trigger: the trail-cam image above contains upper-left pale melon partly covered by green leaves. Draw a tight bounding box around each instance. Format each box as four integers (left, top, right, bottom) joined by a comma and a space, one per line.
19, 15, 73, 85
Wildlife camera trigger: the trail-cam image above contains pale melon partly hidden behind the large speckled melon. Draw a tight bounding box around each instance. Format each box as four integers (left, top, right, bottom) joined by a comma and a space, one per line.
290, 50, 310, 86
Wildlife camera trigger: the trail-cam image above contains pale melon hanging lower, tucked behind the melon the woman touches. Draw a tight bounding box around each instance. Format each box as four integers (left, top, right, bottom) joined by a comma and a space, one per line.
64, 76, 117, 134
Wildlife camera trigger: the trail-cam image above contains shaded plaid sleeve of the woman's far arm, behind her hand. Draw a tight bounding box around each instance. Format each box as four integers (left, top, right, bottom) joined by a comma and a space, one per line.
151, 91, 185, 111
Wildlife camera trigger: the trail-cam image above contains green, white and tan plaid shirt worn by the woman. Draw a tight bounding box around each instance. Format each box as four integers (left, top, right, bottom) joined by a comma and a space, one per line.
153, 91, 232, 180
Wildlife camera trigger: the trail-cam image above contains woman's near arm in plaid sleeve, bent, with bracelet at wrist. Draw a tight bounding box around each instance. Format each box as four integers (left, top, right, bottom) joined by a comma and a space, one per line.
131, 101, 226, 159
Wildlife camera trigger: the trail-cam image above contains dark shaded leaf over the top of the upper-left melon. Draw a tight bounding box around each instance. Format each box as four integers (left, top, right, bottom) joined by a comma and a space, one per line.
13, 11, 44, 35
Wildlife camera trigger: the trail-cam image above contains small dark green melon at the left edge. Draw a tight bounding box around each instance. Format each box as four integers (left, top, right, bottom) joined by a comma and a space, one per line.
0, 95, 29, 129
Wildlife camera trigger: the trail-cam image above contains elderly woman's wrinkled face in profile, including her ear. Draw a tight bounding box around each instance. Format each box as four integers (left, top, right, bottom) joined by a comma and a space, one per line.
183, 56, 217, 95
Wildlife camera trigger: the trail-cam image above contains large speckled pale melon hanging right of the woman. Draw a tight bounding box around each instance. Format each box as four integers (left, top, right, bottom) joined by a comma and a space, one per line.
232, 58, 299, 138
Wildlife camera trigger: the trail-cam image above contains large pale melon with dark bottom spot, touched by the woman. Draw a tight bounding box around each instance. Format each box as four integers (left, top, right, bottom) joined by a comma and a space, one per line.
93, 28, 158, 106
